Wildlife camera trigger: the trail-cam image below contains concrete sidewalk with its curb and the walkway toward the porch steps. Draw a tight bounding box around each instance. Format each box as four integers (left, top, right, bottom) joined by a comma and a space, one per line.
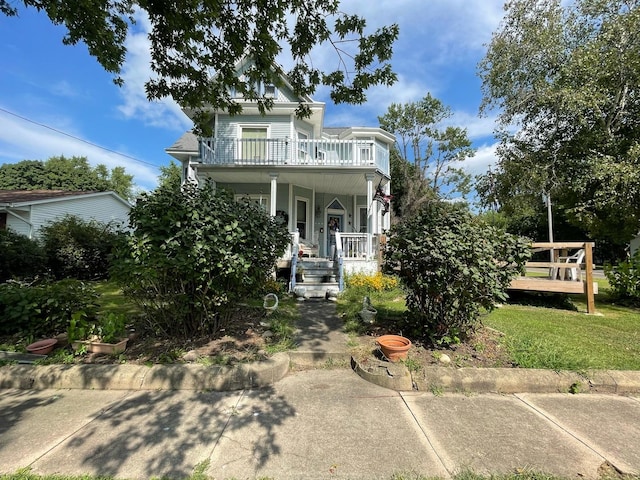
0, 301, 640, 480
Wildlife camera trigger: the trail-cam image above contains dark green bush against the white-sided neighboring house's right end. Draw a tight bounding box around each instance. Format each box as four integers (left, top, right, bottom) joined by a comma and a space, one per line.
41, 215, 118, 280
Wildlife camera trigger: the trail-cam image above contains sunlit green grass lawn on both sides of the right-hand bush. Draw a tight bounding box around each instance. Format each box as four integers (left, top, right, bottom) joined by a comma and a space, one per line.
339, 279, 640, 372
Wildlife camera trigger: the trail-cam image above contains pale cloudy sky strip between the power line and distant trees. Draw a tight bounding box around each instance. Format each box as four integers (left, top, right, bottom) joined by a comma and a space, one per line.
0, 112, 159, 189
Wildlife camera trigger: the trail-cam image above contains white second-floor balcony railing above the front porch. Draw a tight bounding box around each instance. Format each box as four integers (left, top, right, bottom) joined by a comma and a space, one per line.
200, 138, 389, 174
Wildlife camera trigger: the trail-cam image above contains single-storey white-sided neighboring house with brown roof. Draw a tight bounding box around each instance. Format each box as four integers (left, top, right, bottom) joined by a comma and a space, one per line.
0, 190, 131, 238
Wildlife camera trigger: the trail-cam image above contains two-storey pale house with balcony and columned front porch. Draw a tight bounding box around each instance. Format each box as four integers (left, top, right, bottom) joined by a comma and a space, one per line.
166, 60, 395, 294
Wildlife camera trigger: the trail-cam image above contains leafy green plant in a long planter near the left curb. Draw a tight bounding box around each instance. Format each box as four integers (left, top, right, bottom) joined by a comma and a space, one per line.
67, 312, 129, 355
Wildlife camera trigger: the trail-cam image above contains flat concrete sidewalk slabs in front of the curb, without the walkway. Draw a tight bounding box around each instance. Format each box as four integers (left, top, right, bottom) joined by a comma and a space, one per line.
0, 369, 640, 480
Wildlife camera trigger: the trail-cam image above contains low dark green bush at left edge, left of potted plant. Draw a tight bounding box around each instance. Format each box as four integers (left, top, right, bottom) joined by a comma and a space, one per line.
0, 280, 98, 337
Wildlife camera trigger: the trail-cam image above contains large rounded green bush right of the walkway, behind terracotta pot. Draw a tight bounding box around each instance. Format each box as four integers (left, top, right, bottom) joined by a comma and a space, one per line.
384, 202, 530, 344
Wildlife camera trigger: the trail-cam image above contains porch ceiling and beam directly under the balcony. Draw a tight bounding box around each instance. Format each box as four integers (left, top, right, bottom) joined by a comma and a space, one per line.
198, 165, 389, 195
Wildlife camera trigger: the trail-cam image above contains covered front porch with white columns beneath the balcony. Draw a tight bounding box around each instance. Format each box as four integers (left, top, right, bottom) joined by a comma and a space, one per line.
194, 164, 390, 263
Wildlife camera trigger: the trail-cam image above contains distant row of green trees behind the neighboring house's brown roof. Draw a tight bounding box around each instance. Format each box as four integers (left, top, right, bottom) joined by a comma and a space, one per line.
0, 156, 133, 200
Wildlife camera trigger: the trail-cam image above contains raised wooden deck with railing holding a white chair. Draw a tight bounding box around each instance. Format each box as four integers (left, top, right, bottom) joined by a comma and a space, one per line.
509, 242, 598, 313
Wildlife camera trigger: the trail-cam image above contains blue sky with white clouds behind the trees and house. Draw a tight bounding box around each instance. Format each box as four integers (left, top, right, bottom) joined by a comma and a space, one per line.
0, 0, 503, 190
